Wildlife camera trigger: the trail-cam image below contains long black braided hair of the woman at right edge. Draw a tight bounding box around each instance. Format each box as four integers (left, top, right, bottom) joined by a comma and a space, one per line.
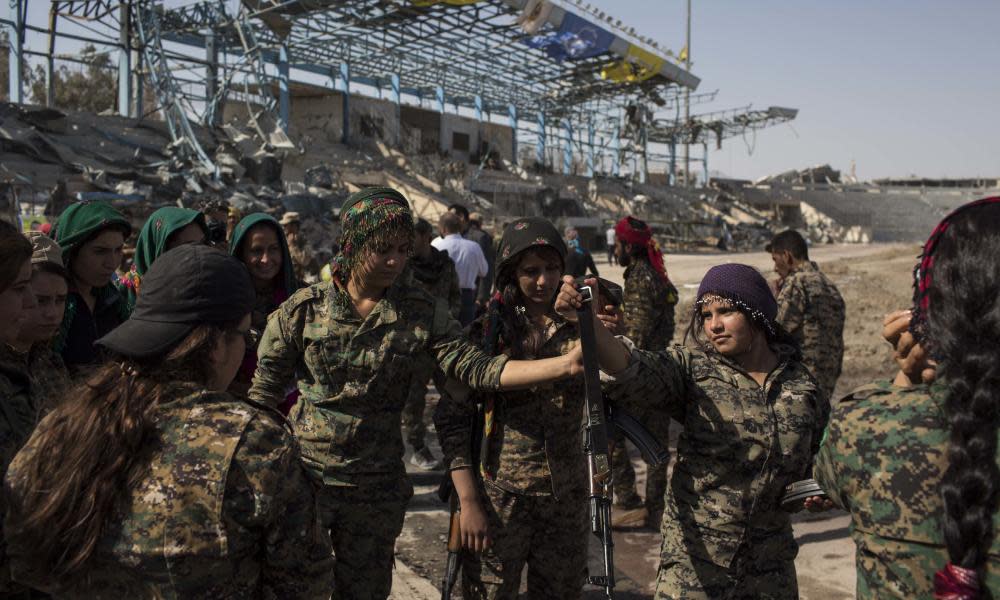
927, 203, 1000, 590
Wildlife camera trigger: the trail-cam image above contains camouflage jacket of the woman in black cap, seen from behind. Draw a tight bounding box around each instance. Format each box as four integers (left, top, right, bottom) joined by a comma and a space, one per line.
5, 384, 333, 600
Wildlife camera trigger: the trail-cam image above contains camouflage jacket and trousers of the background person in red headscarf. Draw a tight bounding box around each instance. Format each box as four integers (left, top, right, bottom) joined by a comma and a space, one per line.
611, 259, 677, 523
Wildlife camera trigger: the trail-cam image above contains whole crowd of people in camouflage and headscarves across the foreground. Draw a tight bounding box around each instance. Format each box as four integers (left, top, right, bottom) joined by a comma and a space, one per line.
0, 187, 1000, 600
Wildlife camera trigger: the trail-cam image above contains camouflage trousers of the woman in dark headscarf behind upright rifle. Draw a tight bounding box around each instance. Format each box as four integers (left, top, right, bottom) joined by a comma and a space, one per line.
462, 484, 588, 600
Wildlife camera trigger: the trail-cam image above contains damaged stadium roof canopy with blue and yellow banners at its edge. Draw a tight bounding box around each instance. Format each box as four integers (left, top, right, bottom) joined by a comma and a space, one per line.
161, 0, 699, 116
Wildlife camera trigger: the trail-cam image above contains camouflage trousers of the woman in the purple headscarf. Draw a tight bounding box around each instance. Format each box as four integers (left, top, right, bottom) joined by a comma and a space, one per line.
654, 516, 799, 600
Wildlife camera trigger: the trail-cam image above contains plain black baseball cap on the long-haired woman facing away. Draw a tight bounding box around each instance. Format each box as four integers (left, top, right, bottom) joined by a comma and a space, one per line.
97, 244, 254, 359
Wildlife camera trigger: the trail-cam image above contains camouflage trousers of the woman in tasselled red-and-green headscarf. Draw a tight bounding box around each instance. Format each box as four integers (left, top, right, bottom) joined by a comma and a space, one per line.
318, 476, 413, 600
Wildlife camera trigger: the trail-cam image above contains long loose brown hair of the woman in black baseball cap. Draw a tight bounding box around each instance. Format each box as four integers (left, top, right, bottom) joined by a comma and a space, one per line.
7, 323, 237, 579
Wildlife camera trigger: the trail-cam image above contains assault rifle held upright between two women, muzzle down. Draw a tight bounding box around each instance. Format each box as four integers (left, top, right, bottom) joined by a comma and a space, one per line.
577, 280, 669, 598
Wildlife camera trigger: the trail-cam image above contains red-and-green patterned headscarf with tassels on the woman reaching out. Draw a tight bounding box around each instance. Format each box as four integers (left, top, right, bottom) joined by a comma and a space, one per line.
331, 187, 413, 284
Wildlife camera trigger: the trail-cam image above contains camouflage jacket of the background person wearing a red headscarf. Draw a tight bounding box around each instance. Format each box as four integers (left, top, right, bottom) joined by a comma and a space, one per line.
624, 260, 677, 350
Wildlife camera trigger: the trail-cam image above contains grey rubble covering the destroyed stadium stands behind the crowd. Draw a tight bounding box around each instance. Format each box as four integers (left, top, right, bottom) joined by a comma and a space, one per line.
0, 104, 773, 256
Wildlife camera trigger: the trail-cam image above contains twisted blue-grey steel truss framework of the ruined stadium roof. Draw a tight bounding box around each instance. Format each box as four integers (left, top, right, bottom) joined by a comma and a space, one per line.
13, 0, 698, 179
